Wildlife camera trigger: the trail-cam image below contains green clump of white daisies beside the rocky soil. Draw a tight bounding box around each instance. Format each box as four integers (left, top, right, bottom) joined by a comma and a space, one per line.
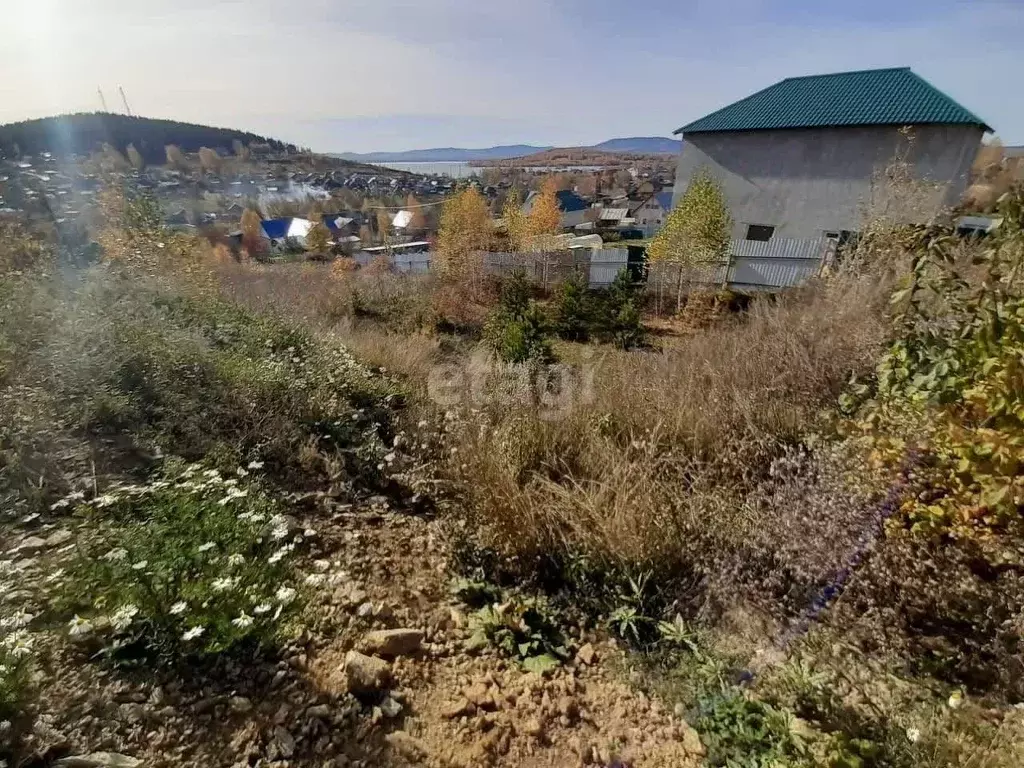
63, 465, 302, 659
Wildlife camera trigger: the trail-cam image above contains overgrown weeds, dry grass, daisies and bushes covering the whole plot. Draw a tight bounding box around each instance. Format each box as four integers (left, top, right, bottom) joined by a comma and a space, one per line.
6, 162, 1024, 768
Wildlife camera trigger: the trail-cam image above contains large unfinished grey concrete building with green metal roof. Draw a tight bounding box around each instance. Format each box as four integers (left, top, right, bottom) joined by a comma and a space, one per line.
674, 68, 991, 241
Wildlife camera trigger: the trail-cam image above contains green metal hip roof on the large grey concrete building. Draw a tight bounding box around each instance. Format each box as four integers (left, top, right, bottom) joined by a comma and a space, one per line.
676, 67, 991, 134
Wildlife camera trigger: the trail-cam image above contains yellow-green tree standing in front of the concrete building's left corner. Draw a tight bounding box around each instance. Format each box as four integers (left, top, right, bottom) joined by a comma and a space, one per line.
647, 168, 732, 311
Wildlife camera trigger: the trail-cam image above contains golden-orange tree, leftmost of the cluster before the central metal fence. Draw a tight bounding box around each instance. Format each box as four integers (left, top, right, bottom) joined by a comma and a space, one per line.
437, 186, 494, 280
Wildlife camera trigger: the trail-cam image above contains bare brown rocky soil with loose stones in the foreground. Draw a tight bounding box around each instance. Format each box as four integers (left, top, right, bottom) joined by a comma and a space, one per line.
4, 499, 702, 768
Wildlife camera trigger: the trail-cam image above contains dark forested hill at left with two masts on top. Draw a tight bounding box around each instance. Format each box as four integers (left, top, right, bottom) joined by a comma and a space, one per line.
0, 112, 295, 163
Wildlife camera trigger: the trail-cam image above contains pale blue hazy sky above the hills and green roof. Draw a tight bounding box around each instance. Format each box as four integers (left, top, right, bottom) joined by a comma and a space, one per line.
0, 0, 1024, 152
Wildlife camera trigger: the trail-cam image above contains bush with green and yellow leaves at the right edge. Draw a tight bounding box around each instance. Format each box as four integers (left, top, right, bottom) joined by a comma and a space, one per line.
843, 190, 1024, 535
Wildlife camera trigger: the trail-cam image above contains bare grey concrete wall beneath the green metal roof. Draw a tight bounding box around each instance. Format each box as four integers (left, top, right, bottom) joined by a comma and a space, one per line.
673, 125, 982, 240
